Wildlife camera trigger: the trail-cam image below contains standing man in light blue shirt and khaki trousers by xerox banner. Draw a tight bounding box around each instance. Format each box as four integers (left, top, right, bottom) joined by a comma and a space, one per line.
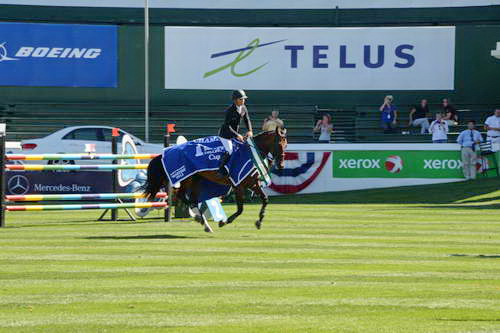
457, 120, 483, 179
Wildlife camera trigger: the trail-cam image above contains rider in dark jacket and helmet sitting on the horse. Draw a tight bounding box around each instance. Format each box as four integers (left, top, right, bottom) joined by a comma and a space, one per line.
219, 90, 253, 176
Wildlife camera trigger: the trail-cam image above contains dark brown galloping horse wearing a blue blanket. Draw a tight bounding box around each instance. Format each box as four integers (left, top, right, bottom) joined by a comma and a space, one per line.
143, 127, 288, 232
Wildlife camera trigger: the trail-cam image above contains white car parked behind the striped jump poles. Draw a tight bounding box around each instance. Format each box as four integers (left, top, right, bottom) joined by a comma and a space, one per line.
21, 126, 163, 164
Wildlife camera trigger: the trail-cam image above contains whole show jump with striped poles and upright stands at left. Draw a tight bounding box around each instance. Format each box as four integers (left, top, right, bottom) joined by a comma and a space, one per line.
0, 124, 175, 227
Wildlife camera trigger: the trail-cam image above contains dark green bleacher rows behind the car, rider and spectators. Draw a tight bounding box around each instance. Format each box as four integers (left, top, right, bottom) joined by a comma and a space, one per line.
0, 104, 494, 143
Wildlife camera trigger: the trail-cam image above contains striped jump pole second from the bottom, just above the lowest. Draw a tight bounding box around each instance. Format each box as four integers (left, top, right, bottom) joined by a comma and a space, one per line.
5, 192, 167, 201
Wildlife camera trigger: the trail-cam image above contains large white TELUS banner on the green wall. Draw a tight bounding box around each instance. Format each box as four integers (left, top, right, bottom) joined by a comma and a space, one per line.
165, 27, 455, 90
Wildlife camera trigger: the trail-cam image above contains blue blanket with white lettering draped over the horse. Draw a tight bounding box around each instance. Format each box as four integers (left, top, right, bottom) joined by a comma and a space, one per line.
162, 136, 256, 191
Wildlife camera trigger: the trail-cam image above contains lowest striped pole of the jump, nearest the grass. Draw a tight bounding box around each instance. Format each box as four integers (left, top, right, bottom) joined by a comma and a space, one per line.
5, 202, 167, 212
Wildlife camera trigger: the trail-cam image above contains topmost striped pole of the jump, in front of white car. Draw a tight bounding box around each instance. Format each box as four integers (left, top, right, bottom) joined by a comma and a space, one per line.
5, 154, 158, 161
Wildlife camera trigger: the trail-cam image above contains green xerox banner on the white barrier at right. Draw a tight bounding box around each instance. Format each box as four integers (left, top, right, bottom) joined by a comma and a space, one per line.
333, 150, 468, 178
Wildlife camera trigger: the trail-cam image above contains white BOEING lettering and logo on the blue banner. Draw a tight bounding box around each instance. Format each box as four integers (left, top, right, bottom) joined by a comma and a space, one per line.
0, 42, 102, 62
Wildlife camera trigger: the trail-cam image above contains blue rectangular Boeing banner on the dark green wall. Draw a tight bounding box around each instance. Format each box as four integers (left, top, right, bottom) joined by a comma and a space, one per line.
0, 22, 118, 88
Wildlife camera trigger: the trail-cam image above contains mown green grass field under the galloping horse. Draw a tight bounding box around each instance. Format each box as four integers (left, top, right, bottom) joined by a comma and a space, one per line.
0, 179, 500, 332
